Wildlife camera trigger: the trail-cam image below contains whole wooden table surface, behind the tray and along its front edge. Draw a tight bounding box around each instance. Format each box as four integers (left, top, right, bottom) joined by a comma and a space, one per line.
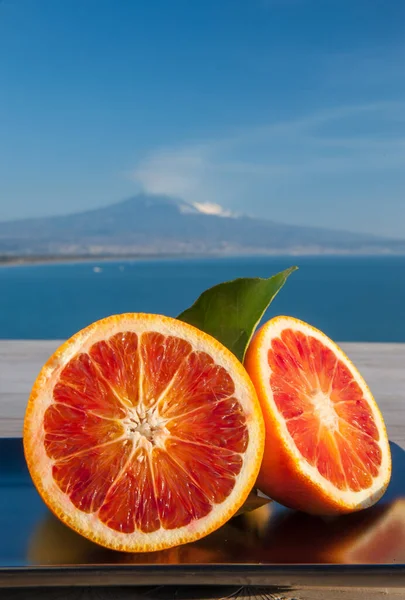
0, 340, 405, 600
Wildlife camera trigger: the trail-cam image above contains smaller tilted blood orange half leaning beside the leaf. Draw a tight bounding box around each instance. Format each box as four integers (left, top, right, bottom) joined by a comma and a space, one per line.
245, 317, 391, 515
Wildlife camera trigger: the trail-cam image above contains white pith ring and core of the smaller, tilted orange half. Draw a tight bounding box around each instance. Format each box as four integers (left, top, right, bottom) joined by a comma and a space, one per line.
258, 317, 391, 507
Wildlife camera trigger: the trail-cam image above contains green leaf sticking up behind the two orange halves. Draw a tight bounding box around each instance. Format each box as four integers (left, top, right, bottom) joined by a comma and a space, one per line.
177, 267, 297, 362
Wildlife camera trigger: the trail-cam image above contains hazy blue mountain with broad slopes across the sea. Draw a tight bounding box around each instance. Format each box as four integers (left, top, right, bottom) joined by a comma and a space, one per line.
0, 194, 405, 255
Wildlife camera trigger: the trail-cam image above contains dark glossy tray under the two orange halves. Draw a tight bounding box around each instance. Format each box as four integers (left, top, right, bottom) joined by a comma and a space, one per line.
0, 438, 405, 587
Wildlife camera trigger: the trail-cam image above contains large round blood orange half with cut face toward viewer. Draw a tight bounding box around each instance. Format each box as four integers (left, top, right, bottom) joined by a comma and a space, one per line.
24, 314, 264, 552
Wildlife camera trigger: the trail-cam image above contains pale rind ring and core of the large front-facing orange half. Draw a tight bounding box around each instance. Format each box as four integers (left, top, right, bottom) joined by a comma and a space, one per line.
24, 315, 263, 549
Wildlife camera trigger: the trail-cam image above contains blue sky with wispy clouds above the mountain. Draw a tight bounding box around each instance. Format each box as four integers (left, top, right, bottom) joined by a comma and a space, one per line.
0, 0, 405, 238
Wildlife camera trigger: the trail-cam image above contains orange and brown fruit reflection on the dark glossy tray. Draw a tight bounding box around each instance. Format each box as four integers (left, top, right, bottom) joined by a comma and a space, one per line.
28, 498, 405, 565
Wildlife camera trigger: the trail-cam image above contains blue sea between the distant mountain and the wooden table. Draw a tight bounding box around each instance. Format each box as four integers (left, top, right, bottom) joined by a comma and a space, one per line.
0, 256, 405, 342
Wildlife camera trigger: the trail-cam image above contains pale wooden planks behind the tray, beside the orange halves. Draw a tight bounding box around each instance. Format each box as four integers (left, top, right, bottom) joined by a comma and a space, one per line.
0, 340, 405, 448
